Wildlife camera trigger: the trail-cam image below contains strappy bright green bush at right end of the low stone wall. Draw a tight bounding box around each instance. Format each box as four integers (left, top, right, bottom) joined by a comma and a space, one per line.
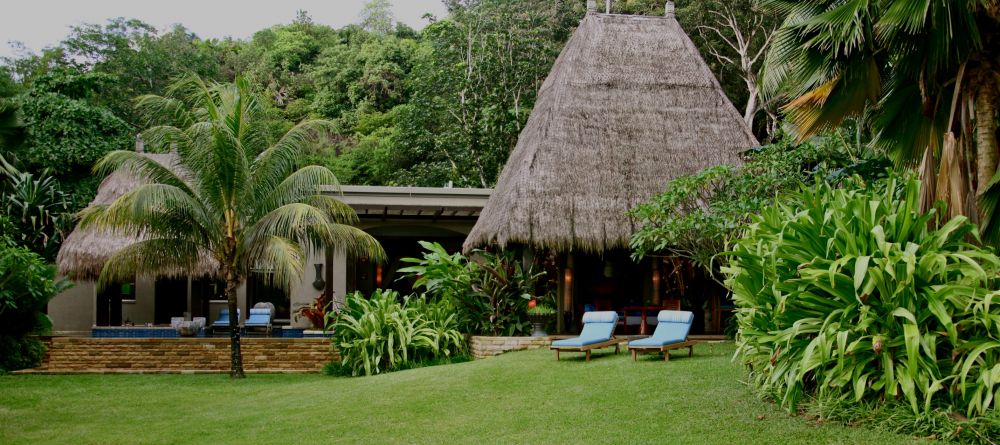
330, 289, 465, 376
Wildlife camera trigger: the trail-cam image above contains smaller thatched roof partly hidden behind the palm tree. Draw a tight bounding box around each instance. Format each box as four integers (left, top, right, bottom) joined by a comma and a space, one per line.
56, 153, 218, 280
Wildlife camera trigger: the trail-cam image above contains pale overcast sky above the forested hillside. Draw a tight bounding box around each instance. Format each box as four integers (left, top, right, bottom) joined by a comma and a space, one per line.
0, 0, 446, 57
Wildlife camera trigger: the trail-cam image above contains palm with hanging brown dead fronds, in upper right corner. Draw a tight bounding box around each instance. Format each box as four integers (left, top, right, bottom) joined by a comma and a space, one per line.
761, 0, 1000, 238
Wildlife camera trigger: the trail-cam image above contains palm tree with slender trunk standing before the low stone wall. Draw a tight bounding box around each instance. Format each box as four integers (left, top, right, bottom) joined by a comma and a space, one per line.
80, 76, 384, 378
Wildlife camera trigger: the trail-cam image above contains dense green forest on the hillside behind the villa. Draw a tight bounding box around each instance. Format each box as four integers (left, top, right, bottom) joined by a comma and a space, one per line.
0, 0, 776, 215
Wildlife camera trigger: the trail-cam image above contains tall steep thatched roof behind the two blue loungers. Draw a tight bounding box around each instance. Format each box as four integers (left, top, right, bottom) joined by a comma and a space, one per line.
465, 13, 758, 253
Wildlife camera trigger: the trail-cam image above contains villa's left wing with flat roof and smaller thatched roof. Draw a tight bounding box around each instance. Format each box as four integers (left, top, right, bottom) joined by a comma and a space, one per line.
48, 153, 490, 335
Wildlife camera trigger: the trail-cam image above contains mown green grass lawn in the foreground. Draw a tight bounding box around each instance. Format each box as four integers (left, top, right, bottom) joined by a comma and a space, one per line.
0, 344, 914, 445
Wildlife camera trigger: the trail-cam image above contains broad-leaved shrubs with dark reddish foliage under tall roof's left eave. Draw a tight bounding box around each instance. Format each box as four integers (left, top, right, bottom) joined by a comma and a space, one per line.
399, 241, 545, 336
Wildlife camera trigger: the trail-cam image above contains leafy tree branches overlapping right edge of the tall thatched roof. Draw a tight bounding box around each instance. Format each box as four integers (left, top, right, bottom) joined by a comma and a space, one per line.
630, 132, 888, 276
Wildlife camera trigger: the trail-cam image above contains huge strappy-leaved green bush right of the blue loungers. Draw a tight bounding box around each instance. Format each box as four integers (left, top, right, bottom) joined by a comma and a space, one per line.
724, 175, 1000, 416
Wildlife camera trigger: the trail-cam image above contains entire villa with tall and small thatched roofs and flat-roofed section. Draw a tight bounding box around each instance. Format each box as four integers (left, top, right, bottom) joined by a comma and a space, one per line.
49, 2, 757, 333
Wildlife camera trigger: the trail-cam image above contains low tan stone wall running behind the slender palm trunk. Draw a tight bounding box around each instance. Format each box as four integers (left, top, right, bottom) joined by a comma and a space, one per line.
34, 337, 340, 373
